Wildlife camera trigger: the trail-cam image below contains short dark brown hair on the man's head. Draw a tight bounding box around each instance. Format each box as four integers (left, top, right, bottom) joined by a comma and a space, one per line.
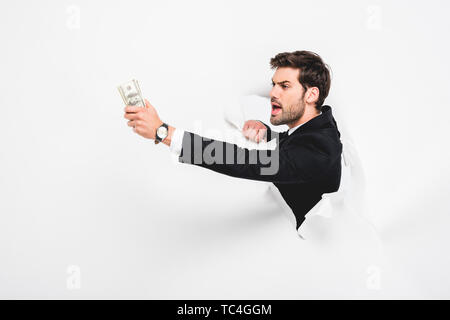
270, 51, 331, 110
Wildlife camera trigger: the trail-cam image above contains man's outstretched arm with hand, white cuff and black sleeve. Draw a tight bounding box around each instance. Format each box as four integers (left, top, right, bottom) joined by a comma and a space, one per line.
125, 101, 336, 183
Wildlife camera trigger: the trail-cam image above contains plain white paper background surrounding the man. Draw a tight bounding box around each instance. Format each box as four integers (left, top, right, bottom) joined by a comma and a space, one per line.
0, 0, 450, 299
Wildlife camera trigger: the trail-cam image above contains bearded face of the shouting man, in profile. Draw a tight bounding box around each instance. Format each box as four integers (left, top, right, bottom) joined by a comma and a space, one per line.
270, 67, 305, 126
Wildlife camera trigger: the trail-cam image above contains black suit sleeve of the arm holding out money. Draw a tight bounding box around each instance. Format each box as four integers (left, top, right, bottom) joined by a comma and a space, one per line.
179, 131, 335, 183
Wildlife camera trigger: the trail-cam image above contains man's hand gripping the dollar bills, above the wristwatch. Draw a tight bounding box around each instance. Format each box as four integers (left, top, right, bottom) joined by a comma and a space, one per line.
124, 100, 163, 139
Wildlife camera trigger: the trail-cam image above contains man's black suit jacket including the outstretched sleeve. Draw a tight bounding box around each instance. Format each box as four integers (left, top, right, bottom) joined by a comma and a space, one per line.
179, 106, 342, 228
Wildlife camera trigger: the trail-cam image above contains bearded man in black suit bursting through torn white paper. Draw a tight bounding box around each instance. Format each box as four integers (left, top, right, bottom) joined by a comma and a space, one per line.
125, 51, 342, 229
